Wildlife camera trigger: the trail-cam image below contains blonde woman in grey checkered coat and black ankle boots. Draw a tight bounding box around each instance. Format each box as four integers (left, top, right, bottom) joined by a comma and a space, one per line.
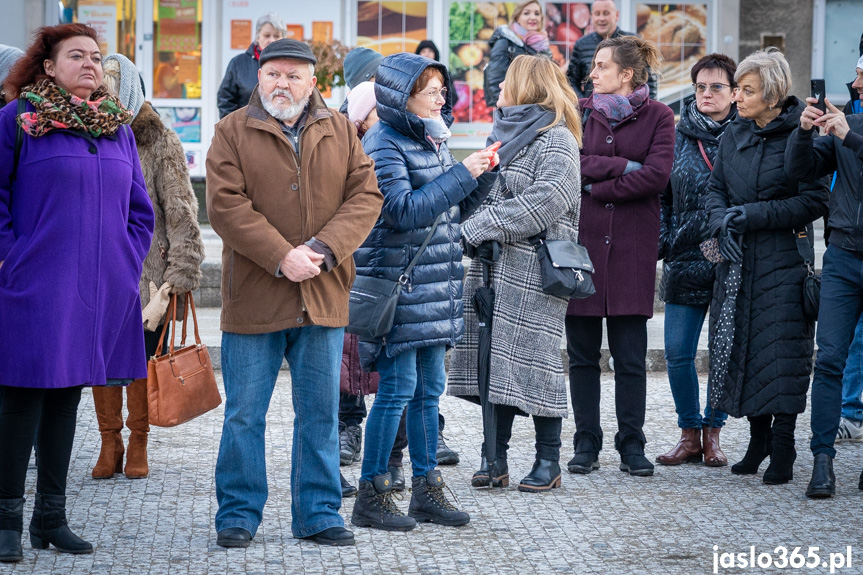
448, 55, 581, 491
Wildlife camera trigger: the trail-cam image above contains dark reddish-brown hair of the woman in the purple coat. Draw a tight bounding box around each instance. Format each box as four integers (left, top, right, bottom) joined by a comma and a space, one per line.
5, 23, 99, 100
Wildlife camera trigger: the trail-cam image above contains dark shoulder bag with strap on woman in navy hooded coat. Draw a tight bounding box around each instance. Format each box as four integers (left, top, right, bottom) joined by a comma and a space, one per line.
345, 214, 443, 340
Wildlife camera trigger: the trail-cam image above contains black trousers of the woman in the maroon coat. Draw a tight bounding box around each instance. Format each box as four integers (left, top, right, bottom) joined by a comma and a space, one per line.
566, 315, 647, 446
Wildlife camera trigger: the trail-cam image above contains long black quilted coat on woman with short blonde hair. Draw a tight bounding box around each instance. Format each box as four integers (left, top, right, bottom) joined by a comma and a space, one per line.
707, 96, 828, 417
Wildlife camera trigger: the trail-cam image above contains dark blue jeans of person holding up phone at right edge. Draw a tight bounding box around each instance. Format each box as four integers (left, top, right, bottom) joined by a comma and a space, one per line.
809, 244, 863, 457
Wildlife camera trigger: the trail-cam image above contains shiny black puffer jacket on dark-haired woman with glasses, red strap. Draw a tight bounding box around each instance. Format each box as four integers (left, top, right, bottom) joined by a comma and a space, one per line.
659, 95, 737, 305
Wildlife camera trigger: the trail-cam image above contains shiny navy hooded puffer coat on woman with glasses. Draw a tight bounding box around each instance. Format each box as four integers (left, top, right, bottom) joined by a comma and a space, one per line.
354, 53, 483, 371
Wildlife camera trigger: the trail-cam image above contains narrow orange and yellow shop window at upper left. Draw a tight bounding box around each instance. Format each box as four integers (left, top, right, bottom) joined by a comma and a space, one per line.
153, 0, 201, 99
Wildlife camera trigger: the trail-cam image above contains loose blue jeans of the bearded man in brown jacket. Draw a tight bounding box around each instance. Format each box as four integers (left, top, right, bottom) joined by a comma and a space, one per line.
216, 326, 344, 537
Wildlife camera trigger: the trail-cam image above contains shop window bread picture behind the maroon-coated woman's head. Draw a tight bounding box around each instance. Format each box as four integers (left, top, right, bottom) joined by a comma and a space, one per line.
635, 3, 707, 100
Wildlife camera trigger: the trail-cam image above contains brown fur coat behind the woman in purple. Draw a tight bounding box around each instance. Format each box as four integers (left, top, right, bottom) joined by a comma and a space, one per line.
132, 102, 204, 319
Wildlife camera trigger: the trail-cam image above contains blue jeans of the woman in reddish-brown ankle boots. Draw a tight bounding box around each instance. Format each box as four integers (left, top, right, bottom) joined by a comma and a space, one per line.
665, 304, 728, 429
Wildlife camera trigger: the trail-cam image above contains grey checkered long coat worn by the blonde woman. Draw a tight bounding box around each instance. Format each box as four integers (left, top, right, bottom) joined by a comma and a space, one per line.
447, 125, 581, 417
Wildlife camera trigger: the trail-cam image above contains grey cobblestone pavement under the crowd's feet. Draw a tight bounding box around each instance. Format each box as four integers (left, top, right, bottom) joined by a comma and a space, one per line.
6, 372, 863, 575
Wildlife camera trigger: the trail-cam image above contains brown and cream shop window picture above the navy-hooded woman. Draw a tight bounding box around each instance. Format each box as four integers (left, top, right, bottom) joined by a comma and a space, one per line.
357, 0, 428, 56
